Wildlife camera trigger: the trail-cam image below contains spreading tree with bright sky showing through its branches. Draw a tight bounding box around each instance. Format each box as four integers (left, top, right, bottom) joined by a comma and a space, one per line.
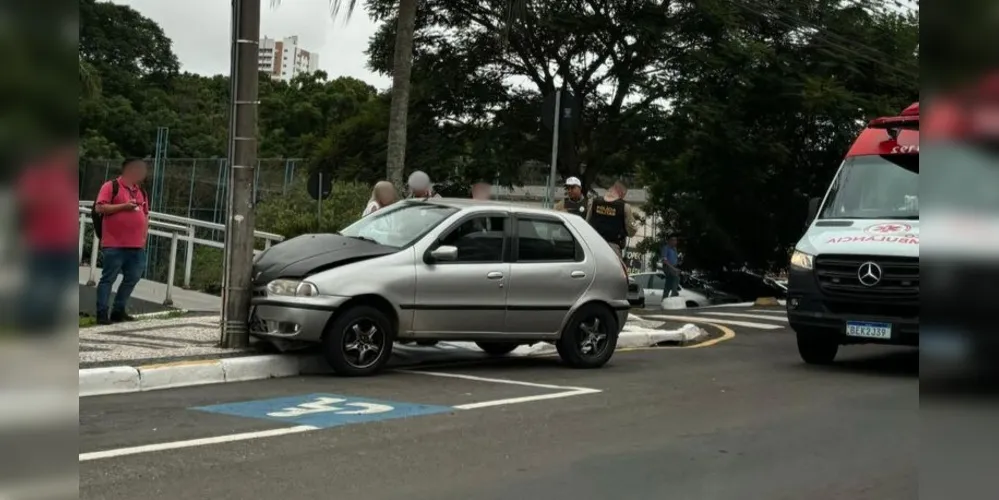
369, 0, 677, 191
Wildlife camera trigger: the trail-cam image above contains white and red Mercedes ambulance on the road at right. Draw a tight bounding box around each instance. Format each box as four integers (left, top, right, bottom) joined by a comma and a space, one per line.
787, 103, 919, 364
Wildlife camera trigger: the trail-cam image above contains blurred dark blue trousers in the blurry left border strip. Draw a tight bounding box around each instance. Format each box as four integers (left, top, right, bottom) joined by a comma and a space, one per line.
18, 252, 79, 330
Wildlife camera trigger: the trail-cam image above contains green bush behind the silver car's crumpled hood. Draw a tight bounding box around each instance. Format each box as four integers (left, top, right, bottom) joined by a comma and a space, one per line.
256, 181, 371, 239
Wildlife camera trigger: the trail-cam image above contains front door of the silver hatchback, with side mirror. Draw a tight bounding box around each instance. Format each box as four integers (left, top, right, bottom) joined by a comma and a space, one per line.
413, 213, 511, 337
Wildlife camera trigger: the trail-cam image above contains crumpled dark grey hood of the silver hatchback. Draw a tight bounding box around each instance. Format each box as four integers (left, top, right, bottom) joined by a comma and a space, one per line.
253, 233, 399, 286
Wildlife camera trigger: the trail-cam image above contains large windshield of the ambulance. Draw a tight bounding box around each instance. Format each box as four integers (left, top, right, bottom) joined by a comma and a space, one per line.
819, 154, 919, 220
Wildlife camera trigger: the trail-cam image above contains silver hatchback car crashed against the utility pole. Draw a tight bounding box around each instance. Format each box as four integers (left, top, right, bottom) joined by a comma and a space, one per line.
250, 199, 629, 375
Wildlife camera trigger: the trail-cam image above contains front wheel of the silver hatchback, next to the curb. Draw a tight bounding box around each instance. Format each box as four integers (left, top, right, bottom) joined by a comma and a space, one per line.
322, 305, 395, 377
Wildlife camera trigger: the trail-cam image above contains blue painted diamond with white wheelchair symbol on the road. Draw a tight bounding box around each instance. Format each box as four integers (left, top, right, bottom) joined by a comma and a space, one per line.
191, 394, 454, 428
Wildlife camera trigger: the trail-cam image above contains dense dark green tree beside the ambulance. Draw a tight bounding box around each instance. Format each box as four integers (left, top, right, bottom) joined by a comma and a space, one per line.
641, 0, 919, 269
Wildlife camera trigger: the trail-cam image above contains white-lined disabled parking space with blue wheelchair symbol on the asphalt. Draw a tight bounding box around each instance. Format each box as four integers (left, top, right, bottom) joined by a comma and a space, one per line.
80, 368, 601, 462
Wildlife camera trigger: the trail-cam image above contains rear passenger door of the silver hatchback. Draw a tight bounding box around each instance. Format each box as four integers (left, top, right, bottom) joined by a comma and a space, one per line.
506, 214, 594, 337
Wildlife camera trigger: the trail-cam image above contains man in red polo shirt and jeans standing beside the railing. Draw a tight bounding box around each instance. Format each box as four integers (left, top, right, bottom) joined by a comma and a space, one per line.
94, 159, 149, 325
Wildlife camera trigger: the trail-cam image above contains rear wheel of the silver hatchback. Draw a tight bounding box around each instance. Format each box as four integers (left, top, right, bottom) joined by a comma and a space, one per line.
555, 304, 620, 368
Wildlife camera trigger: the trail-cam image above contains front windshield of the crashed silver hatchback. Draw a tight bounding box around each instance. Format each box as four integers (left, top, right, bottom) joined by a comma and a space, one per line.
340, 201, 458, 248
